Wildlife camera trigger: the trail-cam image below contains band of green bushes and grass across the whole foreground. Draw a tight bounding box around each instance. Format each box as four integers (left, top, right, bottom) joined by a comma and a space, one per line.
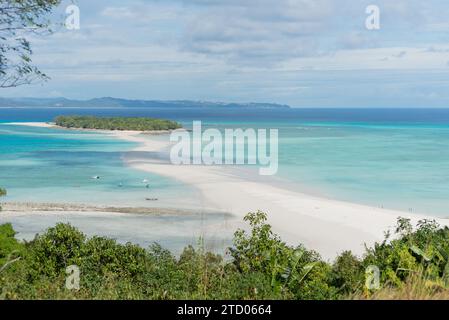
0, 212, 449, 299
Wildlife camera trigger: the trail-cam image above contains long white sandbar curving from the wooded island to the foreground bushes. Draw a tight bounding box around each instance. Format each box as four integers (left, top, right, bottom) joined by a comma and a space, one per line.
6, 123, 449, 259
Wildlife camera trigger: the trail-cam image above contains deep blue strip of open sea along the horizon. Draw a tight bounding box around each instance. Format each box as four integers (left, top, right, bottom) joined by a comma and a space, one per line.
4, 108, 449, 125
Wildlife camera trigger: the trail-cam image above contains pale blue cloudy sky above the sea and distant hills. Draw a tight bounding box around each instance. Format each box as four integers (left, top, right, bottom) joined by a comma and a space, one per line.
0, 0, 449, 108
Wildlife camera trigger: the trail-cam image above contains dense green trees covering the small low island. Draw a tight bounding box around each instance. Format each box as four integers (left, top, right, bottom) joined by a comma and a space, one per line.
54, 116, 182, 131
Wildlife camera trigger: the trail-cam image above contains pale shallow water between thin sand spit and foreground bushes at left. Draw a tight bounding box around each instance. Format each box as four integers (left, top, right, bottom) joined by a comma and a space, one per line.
0, 213, 234, 255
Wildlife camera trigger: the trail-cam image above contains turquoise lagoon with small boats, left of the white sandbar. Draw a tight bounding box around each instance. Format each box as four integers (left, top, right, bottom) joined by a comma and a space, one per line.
0, 124, 200, 207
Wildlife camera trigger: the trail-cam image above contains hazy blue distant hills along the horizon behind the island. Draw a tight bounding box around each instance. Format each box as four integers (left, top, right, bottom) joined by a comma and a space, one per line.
0, 98, 290, 109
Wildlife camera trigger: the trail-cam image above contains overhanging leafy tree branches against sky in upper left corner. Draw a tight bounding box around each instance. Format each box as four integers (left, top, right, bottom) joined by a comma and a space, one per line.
0, 0, 60, 88
